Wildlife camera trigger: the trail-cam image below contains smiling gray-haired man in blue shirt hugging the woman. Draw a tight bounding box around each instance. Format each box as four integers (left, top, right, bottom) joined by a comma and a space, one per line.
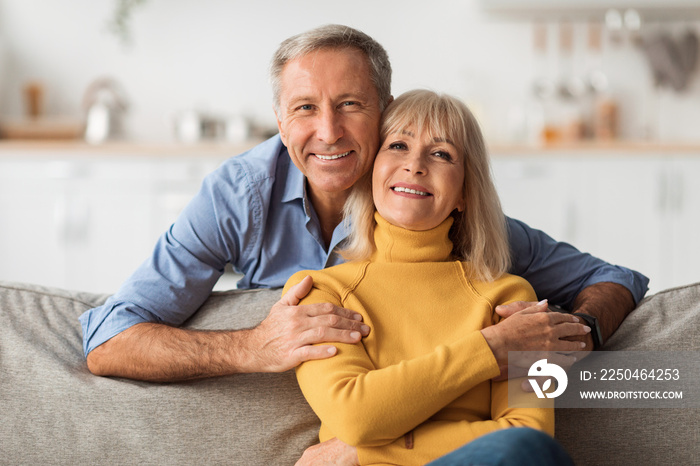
80, 22, 648, 381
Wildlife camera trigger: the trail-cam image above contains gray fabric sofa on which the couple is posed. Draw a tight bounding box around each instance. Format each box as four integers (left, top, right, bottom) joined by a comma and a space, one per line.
0, 282, 700, 465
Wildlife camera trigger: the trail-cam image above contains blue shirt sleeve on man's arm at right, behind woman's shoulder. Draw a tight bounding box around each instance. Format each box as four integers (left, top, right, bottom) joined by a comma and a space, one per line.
507, 218, 649, 309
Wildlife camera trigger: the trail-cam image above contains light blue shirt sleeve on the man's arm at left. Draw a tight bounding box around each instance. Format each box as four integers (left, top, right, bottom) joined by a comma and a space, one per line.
80, 158, 260, 356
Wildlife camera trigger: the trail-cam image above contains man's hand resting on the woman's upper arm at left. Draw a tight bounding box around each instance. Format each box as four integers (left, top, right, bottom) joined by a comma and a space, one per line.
249, 276, 369, 372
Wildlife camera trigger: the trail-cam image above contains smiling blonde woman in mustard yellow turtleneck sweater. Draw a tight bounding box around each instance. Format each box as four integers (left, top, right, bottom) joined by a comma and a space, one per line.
285, 91, 572, 465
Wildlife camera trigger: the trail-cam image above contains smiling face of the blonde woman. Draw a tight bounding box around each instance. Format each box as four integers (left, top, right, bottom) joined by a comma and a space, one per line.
372, 128, 465, 230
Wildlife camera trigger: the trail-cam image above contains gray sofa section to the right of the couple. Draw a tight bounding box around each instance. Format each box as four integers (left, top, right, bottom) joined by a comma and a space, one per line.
555, 283, 700, 466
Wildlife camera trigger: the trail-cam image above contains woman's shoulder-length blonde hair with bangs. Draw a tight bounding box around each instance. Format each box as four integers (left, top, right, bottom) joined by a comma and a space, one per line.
343, 90, 510, 281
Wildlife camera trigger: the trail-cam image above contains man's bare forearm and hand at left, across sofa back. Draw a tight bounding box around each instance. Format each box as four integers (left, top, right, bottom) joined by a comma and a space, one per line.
87, 277, 369, 382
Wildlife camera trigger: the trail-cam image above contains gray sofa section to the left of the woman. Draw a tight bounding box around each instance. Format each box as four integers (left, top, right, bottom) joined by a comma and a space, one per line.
0, 283, 319, 465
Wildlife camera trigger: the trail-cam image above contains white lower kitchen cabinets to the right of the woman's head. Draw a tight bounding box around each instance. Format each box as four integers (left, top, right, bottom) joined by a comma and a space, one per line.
493, 150, 700, 292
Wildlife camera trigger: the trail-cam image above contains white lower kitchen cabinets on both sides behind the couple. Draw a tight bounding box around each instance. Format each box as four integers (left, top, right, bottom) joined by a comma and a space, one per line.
0, 145, 700, 292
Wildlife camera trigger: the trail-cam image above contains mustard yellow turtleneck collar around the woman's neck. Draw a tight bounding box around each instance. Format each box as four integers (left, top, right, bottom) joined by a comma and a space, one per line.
371, 212, 454, 262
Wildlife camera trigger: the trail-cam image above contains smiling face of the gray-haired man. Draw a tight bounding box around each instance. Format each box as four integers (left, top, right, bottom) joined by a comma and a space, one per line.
277, 49, 381, 196
